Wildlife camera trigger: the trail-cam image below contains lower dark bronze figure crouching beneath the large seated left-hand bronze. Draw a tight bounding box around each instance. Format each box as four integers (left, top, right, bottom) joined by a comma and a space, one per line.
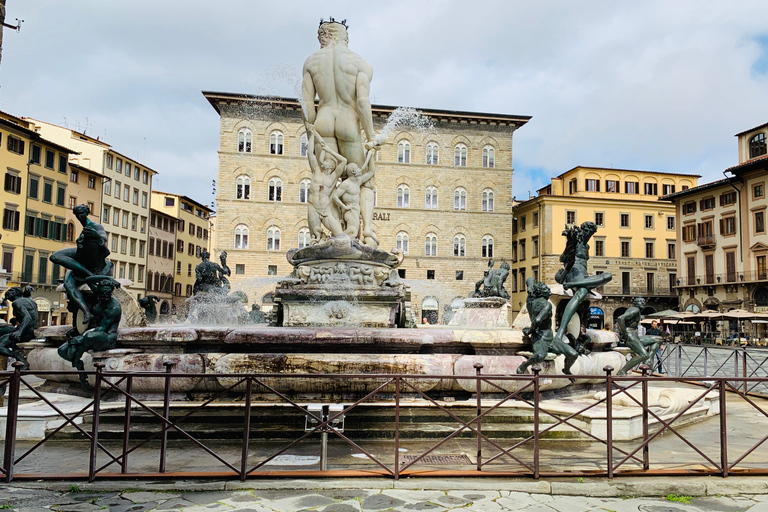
58, 276, 122, 389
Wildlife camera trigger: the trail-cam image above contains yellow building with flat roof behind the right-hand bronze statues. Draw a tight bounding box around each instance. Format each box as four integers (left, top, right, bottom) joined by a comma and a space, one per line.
507, 166, 699, 328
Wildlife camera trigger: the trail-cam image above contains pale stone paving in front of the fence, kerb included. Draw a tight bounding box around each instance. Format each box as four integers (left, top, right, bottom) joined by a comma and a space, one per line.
0, 478, 768, 512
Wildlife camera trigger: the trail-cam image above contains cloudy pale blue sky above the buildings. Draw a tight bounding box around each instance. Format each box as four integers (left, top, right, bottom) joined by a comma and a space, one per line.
0, 0, 768, 203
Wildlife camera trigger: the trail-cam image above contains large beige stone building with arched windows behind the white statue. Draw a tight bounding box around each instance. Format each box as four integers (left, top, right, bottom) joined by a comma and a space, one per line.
203, 92, 530, 323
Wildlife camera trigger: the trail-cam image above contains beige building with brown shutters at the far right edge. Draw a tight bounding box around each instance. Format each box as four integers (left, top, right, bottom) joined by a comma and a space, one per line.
664, 123, 768, 328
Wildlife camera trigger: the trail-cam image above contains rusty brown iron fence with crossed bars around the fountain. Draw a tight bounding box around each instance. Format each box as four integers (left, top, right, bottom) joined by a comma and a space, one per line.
0, 362, 768, 482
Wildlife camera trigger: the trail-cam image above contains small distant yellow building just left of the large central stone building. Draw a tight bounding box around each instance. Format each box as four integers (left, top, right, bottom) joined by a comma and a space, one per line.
152, 190, 213, 315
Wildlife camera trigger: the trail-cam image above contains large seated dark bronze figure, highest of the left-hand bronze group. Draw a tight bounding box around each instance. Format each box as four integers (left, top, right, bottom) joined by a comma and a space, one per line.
51, 204, 114, 325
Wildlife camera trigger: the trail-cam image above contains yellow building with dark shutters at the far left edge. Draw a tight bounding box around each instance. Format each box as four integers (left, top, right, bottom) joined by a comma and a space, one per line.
0, 113, 75, 326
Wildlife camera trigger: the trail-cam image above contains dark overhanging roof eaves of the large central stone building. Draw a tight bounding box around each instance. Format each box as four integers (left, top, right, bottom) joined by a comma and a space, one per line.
202, 91, 531, 127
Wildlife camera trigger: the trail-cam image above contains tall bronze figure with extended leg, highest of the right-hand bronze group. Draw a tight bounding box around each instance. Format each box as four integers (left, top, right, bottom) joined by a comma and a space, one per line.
555, 221, 611, 354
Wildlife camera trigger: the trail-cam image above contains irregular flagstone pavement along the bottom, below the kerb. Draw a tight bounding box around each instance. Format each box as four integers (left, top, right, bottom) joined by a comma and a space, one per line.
0, 480, 768, 512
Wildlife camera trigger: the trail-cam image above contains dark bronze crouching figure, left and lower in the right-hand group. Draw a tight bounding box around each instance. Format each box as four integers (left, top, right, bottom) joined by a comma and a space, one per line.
517, 277, 579, 375
